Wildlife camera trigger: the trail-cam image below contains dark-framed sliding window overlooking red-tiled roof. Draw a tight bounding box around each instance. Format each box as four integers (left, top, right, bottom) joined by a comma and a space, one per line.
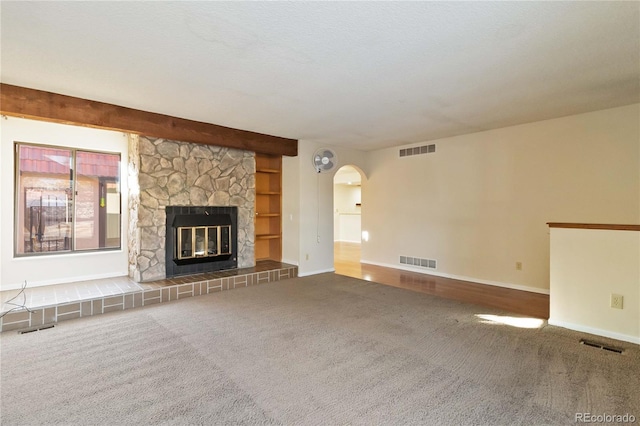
15, 143, 121, 255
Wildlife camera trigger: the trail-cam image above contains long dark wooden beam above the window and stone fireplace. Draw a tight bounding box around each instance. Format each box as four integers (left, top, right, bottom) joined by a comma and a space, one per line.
0, 83, 298, 156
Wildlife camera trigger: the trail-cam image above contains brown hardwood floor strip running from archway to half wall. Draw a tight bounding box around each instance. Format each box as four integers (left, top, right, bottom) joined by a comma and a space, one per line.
334, 242, 549, 319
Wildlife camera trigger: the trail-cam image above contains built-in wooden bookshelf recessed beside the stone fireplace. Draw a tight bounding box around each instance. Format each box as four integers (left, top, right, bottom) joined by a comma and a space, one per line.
254, 154, 282, 261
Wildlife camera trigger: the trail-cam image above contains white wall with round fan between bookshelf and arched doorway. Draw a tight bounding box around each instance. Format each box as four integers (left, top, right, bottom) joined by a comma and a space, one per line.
282, 140, 368, 276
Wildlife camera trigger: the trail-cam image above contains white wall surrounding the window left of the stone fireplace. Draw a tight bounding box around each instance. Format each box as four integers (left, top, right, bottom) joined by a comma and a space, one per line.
0, 117, 128, 290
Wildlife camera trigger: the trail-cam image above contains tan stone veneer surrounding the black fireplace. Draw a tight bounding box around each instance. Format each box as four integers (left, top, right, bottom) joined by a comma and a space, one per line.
128, 135, 256, 282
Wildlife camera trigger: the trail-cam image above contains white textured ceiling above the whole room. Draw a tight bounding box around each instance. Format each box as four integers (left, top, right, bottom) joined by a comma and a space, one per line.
0, 1, 640, 150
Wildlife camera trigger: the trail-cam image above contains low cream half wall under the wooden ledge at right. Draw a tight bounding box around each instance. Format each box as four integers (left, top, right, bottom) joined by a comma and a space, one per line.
549, 228, 640, 344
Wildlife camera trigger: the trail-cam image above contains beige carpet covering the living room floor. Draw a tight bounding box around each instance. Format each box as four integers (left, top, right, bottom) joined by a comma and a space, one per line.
0, 274, 640, 426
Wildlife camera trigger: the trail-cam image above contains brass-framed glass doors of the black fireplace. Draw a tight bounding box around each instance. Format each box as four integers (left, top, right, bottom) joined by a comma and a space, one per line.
176, 225, 231, 260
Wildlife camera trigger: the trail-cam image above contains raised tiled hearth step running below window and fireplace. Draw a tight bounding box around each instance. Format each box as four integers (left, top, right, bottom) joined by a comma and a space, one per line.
0, 260, 298, 332
